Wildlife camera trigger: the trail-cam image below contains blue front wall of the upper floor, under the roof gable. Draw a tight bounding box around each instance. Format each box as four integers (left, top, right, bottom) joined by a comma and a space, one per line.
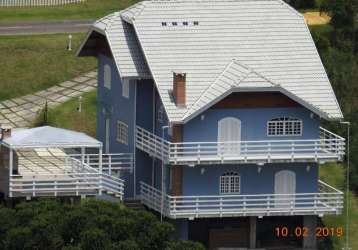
183, 107, 320, 142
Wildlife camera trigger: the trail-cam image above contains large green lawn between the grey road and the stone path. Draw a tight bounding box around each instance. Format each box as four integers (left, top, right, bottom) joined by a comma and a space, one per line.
0, 33, 96, 100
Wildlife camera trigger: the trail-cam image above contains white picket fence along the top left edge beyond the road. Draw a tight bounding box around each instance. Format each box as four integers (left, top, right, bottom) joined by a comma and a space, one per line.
0, 0, 86, 7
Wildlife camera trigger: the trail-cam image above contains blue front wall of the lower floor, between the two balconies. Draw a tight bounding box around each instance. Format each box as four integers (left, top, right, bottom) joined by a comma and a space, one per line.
183, 163, 318, 195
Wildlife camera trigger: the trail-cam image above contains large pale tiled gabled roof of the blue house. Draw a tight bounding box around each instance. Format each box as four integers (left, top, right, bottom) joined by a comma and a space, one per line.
79, 0, 342, 122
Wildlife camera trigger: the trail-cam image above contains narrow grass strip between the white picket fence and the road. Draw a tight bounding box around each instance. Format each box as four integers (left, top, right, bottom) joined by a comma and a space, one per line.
0, 0, 138, 23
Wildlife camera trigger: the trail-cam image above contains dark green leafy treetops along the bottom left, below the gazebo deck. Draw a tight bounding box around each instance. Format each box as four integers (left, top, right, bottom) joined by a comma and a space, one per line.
0, 199, 203, 250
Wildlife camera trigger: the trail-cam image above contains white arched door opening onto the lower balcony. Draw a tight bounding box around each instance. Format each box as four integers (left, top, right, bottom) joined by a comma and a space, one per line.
275, 170, 296, 208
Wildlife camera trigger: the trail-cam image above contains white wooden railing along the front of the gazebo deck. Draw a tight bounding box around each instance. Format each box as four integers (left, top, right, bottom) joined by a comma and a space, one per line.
9, 157, 124, 199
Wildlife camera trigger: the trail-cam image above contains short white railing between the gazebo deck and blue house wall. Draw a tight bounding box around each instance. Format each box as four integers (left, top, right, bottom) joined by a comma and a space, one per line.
70, 153, 134, 175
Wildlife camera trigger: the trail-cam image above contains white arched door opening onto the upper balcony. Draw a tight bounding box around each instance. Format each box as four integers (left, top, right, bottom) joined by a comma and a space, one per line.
218, 117, 241, 155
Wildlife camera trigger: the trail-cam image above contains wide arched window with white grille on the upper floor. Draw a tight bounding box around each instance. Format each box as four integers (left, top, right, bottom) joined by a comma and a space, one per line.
267, 117, 302, 136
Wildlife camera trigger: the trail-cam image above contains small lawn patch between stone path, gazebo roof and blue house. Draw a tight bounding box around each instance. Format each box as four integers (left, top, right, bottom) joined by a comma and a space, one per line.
35, 91, 97, 137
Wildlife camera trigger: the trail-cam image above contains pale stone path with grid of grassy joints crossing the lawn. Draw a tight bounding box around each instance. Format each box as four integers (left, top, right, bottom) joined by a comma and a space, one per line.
0, 71, 97, 128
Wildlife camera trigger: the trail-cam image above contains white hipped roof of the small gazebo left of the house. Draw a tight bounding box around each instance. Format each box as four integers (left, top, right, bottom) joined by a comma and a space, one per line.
2, 126, 102, 148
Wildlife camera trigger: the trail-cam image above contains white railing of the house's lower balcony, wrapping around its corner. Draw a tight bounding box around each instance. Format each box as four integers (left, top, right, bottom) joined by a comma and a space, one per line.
141, 181, 343, 218
